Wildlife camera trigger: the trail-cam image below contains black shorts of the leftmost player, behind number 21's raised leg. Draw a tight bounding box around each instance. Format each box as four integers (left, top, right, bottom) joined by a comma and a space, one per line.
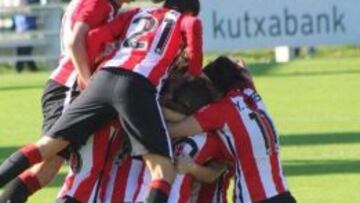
41, 80, 80, 159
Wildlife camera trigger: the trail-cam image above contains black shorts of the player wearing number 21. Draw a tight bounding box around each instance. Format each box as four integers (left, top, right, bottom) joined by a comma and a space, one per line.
48, 68, 172, 158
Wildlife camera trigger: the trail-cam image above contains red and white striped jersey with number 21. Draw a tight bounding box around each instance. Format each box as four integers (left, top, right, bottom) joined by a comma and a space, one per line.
88, 8, 202, 89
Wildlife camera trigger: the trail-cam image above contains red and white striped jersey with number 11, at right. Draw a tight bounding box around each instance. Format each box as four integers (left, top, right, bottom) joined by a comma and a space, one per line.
195, 88, 288, 203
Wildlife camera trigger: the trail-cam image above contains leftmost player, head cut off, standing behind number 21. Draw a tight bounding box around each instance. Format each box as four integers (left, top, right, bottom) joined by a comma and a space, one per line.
0, 0, 130, 203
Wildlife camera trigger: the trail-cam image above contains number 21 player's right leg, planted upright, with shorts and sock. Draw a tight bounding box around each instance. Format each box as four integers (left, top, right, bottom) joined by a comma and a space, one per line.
109, 70, 175, 203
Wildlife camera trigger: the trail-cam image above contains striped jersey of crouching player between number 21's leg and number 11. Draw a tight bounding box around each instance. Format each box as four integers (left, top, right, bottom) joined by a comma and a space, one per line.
168, 133, 224, 203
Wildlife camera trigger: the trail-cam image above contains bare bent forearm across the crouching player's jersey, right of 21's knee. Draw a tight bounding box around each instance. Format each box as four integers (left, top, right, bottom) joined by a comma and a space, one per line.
176, 156, 226, 183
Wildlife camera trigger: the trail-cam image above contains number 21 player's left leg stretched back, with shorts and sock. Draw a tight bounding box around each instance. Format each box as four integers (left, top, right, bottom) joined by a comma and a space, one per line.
0, 74, 115, 187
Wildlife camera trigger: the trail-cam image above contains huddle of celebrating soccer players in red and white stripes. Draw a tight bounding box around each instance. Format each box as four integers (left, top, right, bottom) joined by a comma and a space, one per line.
0, 0, 296, 203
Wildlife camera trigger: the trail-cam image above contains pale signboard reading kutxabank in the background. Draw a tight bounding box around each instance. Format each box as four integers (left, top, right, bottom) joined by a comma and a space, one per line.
200, 0, 360, 51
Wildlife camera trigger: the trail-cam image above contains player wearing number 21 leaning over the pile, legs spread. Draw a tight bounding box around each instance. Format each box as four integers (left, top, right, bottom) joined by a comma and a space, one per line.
0, 0, 202, 202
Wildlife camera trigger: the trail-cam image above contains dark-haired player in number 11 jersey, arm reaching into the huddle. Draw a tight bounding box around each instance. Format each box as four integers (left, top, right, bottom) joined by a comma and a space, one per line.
169, 57, 296, 203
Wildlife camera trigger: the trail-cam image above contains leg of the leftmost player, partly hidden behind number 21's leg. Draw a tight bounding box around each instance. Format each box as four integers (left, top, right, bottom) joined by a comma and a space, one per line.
0, 80, 75, 203
